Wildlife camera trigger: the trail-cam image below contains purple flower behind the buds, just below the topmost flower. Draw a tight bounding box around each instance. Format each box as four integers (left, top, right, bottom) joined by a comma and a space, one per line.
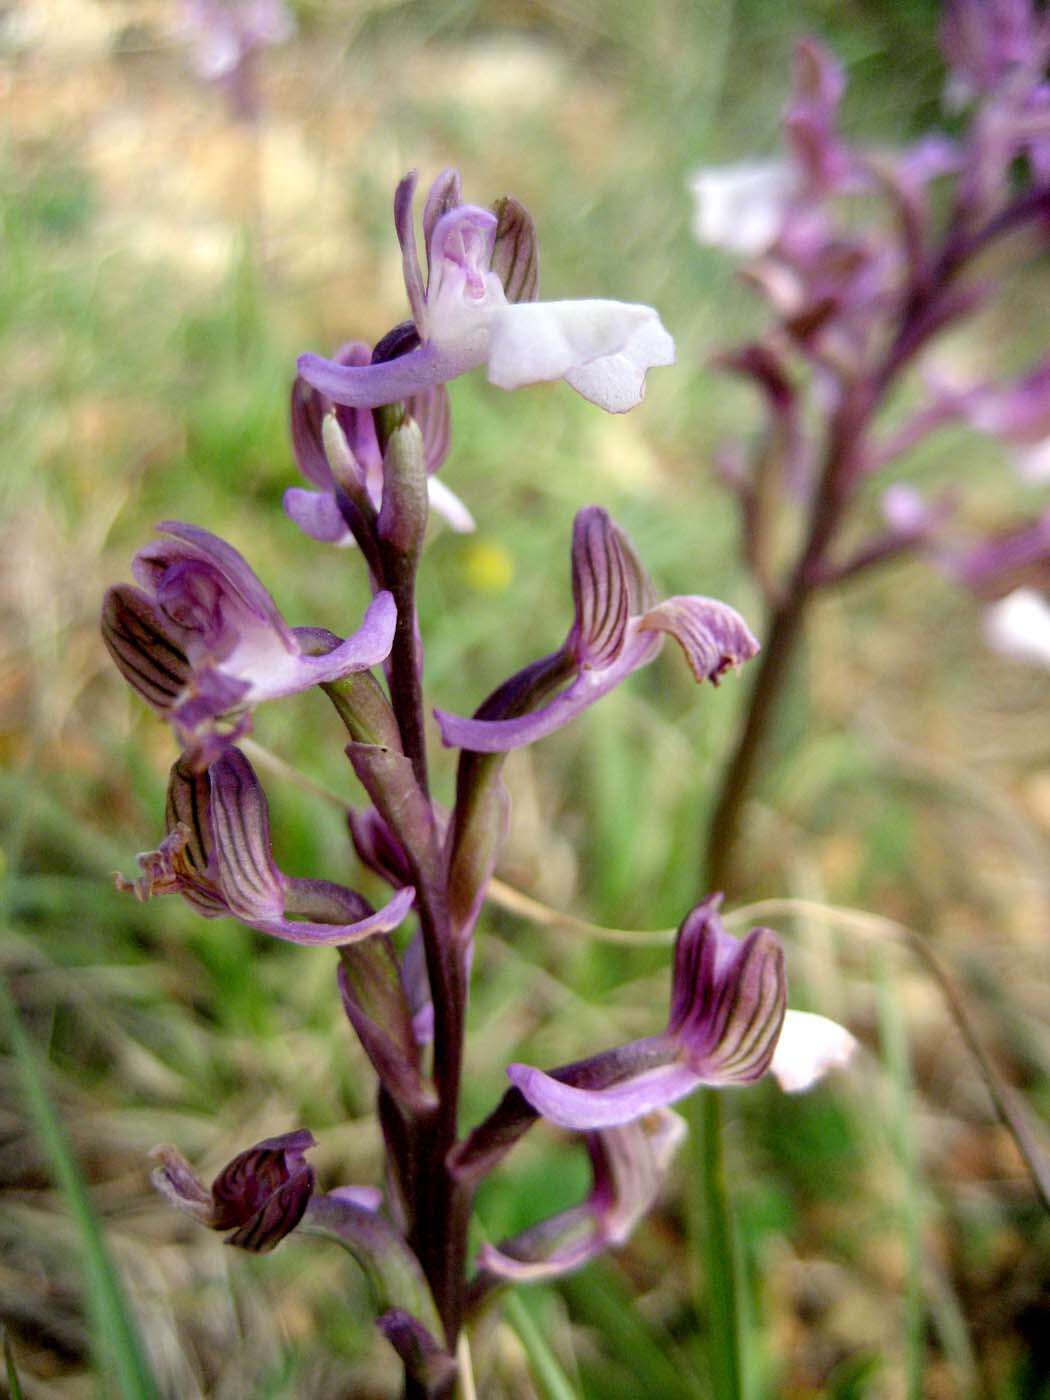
284, 340, 475, 546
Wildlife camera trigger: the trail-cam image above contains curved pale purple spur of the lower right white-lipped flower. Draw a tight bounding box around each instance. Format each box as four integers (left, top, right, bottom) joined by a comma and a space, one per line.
507, 1063, 704, 1131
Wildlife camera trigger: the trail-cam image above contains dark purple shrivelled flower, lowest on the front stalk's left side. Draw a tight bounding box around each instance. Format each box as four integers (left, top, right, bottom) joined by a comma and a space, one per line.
151, 1128, 316, 1254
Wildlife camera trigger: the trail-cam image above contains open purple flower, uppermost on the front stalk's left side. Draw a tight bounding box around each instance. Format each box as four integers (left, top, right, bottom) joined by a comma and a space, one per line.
102, 521, 396, 767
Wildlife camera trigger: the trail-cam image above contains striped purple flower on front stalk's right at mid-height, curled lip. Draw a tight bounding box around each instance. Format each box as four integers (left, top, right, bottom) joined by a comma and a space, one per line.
435, 505, 759, 753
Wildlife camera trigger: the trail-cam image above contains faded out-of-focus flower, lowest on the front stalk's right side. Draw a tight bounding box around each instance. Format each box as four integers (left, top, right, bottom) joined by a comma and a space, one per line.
477, 1109, 686, 1282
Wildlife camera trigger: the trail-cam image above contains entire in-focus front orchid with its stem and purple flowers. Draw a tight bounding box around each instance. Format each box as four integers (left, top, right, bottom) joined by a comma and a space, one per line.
102, 171, 853, 1400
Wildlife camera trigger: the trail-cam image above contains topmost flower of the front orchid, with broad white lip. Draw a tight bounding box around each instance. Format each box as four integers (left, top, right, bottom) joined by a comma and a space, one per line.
300, 171, 675, 413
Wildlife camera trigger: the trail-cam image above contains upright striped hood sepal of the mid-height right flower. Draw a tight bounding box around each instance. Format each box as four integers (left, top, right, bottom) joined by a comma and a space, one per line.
568, 505, 630, 671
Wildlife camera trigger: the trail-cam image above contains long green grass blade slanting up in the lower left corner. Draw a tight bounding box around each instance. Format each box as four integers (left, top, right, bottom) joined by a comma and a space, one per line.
0, 980, 160, 1400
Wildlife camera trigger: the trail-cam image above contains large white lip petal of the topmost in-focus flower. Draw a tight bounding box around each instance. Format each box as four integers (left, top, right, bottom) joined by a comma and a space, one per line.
489, 301, 675, 413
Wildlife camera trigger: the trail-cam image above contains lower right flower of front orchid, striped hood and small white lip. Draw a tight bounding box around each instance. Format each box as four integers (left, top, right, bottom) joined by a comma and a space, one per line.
507, 895, 855, 1130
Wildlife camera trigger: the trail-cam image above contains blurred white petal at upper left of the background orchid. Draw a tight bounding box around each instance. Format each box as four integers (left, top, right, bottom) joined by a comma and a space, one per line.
689, 161, 798, 258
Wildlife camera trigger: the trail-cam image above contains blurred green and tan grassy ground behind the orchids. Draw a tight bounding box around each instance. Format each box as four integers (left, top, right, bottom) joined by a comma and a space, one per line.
0, 0, 1050, 1400
